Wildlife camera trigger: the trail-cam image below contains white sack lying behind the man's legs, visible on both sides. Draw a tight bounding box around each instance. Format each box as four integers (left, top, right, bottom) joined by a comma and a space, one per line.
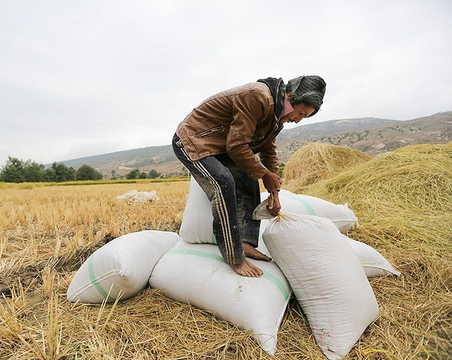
179, 177, 357, 244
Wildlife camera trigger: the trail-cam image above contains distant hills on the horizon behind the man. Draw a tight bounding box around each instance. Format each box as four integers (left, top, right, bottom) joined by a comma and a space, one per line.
56, 111, 452, 178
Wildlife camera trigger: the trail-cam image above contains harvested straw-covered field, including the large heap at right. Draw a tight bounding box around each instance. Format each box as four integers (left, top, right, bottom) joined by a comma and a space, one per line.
0, 144, 452, 360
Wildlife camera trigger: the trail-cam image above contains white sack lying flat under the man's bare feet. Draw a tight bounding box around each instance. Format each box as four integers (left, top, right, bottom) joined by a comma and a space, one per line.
149, 241, 292, 355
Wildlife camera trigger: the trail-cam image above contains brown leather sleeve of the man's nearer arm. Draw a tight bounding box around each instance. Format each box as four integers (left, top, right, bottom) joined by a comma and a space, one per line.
226, 91, 276, 179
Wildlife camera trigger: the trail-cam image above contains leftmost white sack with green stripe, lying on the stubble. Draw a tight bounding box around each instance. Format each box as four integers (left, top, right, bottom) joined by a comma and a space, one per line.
67, 230, 181, 303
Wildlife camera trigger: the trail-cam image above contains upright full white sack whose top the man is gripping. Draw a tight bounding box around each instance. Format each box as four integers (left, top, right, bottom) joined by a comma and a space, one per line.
263, 215, 379, 359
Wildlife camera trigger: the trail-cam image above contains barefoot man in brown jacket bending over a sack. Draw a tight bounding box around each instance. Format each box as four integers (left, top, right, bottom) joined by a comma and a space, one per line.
173, 76, 326, 277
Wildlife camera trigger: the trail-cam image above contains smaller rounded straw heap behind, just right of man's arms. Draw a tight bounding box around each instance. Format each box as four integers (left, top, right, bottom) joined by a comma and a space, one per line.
284, 143, 372, 192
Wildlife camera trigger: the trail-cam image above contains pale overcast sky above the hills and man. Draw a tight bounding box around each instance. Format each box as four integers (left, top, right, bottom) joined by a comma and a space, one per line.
0, 0, 452, 167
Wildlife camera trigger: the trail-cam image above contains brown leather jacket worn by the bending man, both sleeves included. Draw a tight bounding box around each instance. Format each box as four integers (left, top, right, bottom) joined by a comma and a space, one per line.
176, 82, 282, 179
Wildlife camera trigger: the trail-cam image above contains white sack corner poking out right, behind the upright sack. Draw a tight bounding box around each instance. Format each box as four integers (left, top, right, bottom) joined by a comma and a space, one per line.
342, 235, 400, 278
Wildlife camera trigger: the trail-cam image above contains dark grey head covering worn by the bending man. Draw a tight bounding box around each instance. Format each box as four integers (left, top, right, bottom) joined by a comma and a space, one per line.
286, 75, 326, 117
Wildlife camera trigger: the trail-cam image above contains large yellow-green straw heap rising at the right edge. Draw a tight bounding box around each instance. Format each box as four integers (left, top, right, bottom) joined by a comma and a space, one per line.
307, 143, 452, 247
